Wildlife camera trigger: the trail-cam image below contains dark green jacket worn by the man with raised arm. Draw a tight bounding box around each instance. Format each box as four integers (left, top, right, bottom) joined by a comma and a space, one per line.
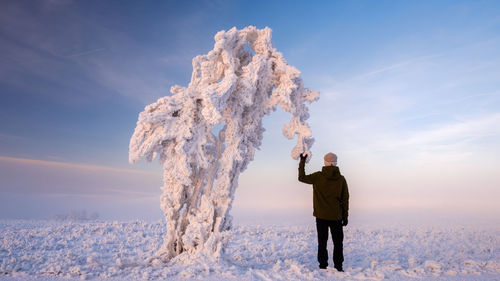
299, 160, 349, 220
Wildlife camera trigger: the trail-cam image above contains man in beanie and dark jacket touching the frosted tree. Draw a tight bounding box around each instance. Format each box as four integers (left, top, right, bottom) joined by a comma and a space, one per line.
299, 152, 349, 271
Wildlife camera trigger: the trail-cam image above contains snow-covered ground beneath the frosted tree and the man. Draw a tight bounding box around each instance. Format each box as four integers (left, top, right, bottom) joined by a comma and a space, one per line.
0, 220, 500, 280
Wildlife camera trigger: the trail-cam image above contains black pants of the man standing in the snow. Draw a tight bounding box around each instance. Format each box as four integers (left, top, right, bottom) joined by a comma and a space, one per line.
316, 218, 344, 268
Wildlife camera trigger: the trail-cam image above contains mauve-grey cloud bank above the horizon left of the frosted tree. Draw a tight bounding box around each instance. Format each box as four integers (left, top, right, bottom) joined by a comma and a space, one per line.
0, 156, 161, 219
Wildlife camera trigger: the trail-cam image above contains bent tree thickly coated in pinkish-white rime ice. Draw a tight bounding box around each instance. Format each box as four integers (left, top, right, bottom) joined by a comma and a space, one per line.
129, 26, 319, 260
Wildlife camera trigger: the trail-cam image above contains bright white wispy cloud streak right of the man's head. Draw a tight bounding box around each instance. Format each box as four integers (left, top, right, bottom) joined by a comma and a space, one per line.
350, 110, 500, 165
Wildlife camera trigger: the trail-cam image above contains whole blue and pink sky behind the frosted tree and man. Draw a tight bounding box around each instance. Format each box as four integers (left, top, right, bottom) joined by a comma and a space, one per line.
0, 0, 500, 223
